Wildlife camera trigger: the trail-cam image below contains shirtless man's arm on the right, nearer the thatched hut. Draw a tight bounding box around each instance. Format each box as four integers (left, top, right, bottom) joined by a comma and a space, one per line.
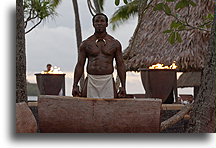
115, 41, 126, 97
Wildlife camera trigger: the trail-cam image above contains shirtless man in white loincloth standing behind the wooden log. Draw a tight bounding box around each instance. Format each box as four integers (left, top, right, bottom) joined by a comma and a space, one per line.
72, 13, 126, 98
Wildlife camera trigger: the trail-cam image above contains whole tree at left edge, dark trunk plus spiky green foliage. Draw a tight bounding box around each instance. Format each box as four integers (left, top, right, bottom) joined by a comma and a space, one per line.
16, 0, 60, 102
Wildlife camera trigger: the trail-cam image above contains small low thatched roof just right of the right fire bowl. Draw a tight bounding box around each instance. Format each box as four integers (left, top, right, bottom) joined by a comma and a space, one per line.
177, 72, 201, 87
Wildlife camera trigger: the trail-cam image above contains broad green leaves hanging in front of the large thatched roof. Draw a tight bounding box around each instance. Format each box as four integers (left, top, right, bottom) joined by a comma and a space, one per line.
153, 0, 214, 44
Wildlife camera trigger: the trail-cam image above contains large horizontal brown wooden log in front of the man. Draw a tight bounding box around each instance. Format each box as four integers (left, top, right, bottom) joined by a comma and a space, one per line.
38, 96, 162, 133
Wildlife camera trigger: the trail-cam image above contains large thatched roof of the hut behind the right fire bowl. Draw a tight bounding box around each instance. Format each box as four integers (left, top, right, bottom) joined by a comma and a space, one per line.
123, 0, 213, 71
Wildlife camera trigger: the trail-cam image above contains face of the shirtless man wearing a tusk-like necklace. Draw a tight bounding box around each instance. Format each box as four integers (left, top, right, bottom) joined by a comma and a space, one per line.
93, 15, 108, 33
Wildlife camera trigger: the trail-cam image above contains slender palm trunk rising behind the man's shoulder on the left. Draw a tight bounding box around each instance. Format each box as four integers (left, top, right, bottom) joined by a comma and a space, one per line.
72, 0, 85, 88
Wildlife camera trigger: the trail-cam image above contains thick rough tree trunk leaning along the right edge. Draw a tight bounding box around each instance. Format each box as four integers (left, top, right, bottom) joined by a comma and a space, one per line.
188, 7, 216, 133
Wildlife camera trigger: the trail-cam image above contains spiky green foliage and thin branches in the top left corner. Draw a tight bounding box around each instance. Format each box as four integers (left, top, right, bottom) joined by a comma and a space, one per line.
23, 0, 60, 33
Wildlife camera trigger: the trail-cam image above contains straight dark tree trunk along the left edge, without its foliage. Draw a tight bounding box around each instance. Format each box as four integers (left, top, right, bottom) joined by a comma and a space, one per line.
16, 0, 27, 102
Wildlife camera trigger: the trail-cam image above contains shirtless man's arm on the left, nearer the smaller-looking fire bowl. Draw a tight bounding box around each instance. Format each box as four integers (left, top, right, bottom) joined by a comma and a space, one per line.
72, 43, 86, 96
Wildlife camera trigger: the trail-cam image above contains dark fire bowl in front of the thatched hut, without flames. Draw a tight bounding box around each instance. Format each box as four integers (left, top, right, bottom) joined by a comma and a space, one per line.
139, 68, 177, 103
